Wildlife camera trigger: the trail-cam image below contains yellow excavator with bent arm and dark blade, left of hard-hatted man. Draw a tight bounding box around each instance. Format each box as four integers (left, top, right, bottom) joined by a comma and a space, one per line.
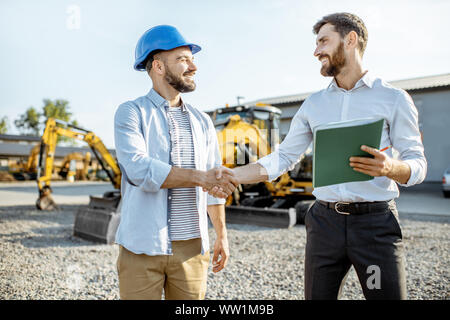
36, 118, 121, 243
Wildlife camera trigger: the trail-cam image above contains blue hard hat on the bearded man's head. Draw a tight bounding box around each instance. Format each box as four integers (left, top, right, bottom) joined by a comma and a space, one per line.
134, 25, 201, 71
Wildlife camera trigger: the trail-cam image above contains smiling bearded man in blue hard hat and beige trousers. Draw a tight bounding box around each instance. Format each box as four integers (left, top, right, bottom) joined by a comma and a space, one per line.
114, 25, 236, 300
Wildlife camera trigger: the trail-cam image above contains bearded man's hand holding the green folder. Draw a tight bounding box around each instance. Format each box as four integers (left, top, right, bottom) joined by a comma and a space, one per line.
350, 145, 394, 177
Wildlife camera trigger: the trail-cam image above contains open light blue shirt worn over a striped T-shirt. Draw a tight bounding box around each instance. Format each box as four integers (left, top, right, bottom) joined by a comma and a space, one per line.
114, 89, 225, 255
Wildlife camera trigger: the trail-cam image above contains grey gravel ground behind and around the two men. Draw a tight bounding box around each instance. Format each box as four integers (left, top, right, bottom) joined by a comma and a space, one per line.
0, 206, 450, 300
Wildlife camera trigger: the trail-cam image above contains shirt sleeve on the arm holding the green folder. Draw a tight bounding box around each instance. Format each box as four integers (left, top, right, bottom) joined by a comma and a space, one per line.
391, 90, 427, 187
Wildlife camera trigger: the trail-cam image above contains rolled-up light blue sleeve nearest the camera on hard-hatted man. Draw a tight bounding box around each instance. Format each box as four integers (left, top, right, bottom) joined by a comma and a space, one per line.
114, 102, 172, 192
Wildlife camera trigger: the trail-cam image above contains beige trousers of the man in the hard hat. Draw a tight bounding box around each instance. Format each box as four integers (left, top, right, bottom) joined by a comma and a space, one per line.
117, 238, 213, 300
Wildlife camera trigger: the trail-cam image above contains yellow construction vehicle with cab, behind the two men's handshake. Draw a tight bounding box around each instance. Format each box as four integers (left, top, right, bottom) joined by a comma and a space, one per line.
210, 104, 314, 227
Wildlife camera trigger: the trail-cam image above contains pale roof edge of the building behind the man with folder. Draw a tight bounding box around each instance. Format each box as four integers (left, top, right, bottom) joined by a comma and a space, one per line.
245, 73, 450, 105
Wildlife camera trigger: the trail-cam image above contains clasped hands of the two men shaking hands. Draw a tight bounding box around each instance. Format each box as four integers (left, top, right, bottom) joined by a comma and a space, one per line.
200, 167, 239, 199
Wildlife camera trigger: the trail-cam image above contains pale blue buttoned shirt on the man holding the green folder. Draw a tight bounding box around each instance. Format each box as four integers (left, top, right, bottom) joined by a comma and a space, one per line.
258, 72, 427, 202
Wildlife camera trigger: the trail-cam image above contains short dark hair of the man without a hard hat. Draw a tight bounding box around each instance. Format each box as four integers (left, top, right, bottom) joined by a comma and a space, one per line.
313, 12, 369, 56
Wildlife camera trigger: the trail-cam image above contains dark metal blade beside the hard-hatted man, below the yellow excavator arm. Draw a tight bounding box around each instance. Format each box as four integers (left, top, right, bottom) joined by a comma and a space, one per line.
73, 192, 120, 244
